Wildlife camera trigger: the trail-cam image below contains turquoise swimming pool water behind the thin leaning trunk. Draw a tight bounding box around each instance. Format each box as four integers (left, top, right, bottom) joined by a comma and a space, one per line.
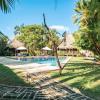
17, 56, 66, 66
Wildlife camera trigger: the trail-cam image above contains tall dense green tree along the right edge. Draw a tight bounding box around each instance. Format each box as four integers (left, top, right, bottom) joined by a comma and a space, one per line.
74, 0, 100, 55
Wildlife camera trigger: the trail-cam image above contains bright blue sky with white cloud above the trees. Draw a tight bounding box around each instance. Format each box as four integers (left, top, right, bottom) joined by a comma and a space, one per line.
0, 0, 78, 39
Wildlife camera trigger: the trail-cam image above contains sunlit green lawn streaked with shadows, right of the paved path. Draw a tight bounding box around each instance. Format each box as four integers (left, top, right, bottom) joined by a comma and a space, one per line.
52, 57, 100, 100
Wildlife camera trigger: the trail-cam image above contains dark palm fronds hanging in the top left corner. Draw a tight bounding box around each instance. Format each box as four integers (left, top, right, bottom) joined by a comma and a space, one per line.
0, 0, 16, 13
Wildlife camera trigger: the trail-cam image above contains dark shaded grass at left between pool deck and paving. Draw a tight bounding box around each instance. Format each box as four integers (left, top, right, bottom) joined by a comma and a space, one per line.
0, 64, 28, 86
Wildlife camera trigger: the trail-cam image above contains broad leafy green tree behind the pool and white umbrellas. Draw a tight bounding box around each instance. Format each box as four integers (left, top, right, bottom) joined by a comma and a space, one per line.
15, 25, 59, 55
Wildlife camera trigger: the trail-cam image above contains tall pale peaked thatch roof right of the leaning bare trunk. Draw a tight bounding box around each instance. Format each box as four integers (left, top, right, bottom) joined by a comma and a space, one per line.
58, 33, 76, 49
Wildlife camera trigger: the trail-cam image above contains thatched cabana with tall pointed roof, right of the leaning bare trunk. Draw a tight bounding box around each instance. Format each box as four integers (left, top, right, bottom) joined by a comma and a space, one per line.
58, 33, 78, 56
